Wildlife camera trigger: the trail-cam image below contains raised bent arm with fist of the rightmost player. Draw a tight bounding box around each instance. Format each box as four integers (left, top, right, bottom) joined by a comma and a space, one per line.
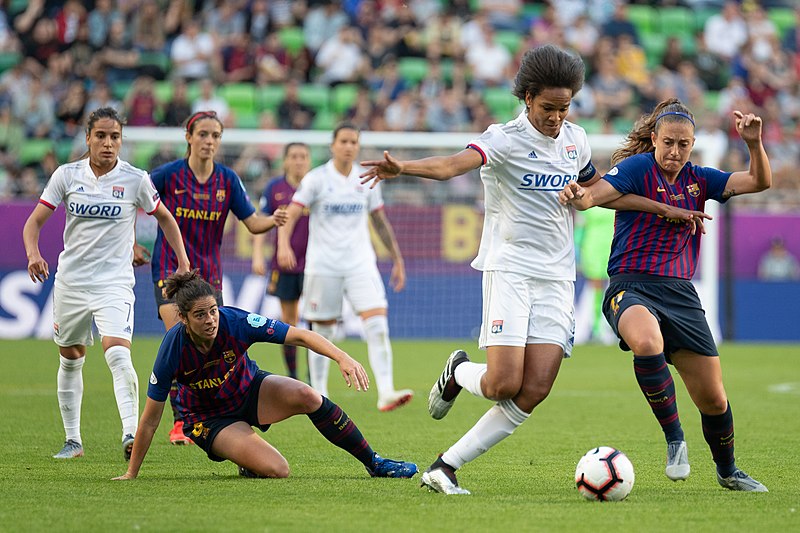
722, 111, 772, 198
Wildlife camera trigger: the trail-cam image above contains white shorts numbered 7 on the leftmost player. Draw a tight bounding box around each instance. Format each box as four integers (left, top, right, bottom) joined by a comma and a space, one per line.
53, 282, 135, 346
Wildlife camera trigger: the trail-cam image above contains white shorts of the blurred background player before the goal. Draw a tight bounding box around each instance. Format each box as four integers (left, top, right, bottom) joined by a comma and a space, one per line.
302, 266, 387, 321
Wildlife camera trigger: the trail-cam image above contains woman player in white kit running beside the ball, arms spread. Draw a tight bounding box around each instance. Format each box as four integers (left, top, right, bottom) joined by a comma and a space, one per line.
362, 45, 708, 494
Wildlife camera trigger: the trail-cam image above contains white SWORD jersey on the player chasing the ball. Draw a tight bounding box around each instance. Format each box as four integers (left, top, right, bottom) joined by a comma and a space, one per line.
468, 113, 595, 281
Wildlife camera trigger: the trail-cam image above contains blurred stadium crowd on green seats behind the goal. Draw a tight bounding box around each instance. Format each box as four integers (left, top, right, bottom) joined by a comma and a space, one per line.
0, 0, 800, 210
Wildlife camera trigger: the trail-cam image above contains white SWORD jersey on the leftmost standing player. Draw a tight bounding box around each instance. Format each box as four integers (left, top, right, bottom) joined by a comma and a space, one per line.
39, 158, 160, 289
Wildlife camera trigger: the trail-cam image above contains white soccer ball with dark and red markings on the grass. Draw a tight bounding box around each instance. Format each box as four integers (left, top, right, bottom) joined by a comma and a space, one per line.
575, 446, 634, 502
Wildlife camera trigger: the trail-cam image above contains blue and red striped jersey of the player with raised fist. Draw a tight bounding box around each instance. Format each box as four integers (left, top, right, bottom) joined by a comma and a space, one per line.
603, 152, 731, 279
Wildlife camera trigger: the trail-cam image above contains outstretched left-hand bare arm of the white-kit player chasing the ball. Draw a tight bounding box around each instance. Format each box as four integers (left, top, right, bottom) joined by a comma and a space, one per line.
361, 148, 483, 187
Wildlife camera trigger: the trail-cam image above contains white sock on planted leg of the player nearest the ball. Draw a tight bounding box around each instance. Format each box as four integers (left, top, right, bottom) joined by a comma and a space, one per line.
442, 400, 530, 468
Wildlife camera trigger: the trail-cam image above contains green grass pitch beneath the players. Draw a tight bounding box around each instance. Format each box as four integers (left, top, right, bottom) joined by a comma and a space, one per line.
0, 338, 800, 532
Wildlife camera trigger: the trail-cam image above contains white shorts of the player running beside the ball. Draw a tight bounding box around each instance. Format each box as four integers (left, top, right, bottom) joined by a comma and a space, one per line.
478, 271, 575, 357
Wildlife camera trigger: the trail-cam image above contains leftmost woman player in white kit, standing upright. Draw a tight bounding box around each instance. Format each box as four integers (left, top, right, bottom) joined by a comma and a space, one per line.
22, 107, 189, 460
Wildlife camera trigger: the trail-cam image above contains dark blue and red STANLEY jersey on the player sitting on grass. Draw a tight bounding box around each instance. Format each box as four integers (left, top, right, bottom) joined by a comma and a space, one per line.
147, 307, 289, 425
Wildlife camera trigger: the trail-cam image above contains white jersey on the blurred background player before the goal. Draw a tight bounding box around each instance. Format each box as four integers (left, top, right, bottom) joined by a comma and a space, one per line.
292, 161, 383, 276
